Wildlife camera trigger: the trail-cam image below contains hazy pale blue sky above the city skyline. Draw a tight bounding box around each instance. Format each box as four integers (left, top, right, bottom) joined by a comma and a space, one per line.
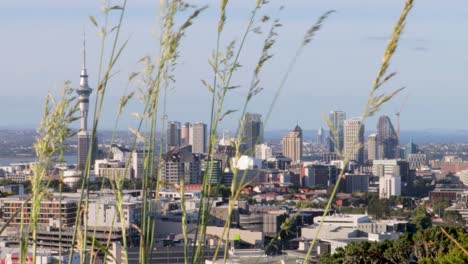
0, 0, 468, 130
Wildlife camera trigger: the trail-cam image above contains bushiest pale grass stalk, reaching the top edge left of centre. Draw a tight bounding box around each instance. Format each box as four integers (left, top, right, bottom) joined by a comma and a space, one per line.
105, 1, 205, 263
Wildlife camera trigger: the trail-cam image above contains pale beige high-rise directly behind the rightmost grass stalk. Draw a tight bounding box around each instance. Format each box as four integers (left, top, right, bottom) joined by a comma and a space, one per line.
343, 118, 364, 163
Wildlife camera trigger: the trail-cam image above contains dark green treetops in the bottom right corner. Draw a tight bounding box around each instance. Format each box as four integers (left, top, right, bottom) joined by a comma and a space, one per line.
319, 227, 468, 264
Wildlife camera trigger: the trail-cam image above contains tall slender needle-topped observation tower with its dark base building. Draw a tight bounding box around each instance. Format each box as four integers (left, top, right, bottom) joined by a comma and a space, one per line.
76, 36, 97, 169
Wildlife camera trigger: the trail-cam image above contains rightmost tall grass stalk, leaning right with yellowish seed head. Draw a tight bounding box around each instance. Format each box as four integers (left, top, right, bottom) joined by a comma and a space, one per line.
304, 0, 413, 264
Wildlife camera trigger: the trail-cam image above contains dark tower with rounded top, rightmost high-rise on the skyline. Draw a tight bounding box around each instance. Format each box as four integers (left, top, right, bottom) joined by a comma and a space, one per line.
377, 115, 399, 159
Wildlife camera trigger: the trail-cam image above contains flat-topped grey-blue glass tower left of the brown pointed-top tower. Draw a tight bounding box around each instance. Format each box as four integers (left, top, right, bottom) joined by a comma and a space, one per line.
242, 113, 263, 155
